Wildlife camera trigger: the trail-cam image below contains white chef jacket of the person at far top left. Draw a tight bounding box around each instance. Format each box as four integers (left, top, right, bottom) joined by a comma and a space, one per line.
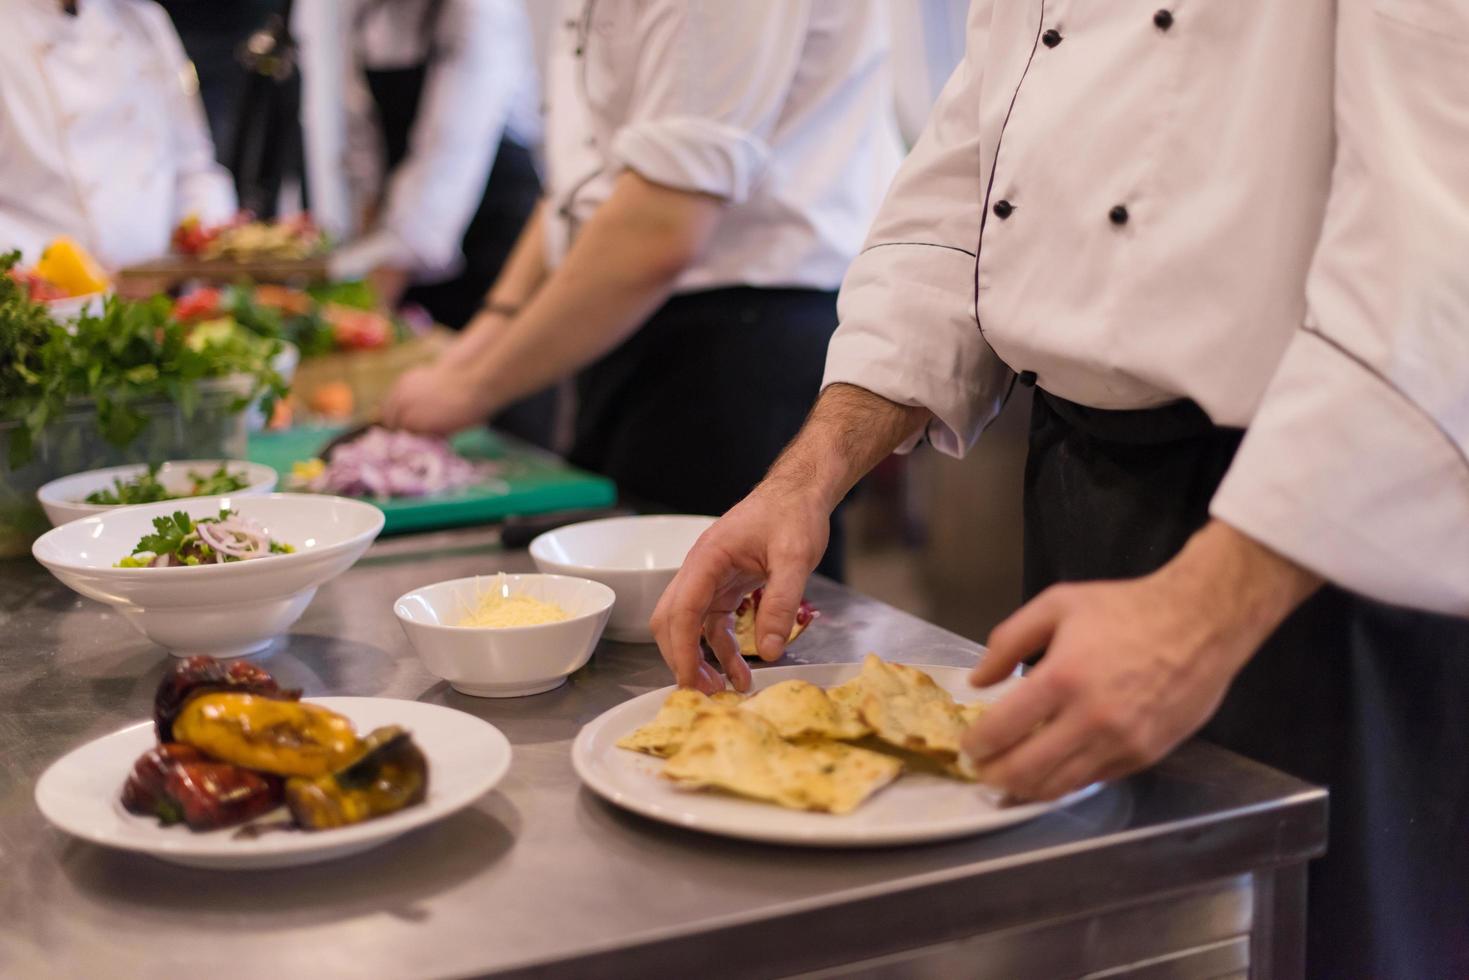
0, 0, 235, 267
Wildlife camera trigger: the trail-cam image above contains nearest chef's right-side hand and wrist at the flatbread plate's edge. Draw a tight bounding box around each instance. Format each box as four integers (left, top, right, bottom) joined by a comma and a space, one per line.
964, 522, 1321, 799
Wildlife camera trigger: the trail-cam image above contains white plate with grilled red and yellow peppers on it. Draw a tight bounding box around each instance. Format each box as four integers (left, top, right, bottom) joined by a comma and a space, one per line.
35, 657, 510, 868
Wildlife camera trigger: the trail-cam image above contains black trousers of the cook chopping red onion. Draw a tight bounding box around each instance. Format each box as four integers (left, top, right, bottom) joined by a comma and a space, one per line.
570, 287, 843, 577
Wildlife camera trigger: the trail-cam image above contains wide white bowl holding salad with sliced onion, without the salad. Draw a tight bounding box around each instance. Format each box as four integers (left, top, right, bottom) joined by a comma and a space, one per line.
31, 494, 383, 657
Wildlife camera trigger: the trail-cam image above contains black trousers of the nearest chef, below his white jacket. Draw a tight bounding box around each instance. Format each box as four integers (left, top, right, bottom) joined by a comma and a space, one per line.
1025, 392, 1469, 980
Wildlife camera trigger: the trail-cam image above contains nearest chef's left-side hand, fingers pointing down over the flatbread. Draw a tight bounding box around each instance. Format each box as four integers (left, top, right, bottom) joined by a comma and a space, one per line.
649, 482, 830, 693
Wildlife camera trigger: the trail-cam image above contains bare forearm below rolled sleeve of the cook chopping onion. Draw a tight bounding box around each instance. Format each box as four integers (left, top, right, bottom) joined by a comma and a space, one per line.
472, 173, 723, 411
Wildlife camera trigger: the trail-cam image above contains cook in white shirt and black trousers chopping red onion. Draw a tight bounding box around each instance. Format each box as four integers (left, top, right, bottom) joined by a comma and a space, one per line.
385, 0, 899, 575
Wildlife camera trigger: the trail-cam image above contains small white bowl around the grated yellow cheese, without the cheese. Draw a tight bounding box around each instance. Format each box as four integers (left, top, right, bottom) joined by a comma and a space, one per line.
392, 574, 616, 698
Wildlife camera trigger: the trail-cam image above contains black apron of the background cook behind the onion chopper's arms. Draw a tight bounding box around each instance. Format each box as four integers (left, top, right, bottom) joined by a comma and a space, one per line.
364, 63, 557, 447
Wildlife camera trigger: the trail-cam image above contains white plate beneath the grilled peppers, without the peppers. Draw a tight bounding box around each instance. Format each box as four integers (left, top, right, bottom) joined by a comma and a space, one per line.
35, 698, 510, 868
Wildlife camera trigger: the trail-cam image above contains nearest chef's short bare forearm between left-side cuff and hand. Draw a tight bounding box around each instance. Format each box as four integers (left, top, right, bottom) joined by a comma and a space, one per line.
761, 385, 930, 510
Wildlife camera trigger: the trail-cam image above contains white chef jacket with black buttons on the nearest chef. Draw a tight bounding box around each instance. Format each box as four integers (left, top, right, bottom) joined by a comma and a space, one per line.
826, 0, 1469, 614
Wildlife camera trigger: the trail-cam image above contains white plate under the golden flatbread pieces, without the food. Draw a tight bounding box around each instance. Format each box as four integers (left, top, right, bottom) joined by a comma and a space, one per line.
571, 664, 1100, 848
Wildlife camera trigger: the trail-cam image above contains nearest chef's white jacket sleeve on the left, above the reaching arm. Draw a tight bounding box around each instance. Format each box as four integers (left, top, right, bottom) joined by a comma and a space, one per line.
823, 3, 1014, 455
